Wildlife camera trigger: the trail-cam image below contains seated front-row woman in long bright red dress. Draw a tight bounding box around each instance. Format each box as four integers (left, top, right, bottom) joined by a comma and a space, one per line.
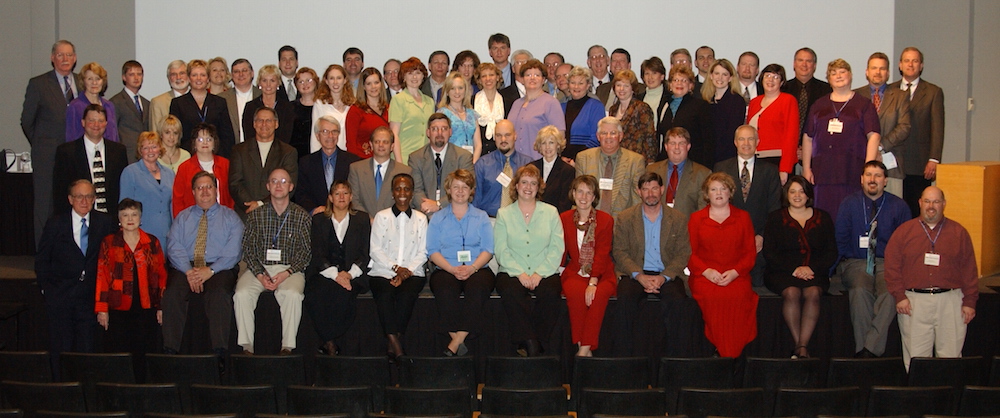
688, 173, 758, 357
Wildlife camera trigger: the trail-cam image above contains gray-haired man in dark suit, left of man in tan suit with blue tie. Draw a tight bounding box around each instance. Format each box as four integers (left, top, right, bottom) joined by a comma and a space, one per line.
295, 115, 359, 214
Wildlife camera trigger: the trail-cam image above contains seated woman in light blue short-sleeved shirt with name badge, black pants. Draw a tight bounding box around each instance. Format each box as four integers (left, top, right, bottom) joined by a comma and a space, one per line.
427, 169, 495, 357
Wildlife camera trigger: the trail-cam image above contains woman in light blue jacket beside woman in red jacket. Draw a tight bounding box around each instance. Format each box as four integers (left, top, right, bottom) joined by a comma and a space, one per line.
121, 132, 174, 242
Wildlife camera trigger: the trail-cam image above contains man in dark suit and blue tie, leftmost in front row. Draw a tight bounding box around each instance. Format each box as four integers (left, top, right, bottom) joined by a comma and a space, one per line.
35, 179, 112, 373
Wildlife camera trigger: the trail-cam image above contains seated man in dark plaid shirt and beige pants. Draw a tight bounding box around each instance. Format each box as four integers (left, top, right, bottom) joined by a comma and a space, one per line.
233, 167, 312, 355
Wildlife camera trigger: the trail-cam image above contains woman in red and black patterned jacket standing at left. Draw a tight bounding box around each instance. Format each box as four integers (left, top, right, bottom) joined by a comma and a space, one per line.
94, 198, 167, 376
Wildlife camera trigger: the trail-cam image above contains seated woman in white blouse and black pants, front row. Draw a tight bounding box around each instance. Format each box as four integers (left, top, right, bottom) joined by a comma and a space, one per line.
369, 173, 427, 363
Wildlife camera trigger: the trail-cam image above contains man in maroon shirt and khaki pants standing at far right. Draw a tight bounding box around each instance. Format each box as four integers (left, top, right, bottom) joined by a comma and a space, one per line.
885, 186, 979, 370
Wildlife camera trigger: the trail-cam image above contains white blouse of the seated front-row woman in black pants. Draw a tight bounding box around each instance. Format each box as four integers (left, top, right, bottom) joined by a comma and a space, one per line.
369, 205, 427, 279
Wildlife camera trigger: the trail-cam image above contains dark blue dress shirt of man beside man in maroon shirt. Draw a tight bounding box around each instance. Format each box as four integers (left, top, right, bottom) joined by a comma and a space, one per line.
834, 190, 912, 260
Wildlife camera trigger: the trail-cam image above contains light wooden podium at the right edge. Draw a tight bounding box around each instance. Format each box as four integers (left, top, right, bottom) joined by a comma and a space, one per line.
937, 161, 1000, 277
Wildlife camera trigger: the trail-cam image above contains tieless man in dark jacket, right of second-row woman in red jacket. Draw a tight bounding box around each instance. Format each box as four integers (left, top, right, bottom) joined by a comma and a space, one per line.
229, 107, 299, 221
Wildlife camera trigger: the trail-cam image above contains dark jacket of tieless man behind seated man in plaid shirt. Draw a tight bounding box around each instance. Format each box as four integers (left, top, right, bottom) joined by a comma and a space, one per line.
229, 140, 299, 220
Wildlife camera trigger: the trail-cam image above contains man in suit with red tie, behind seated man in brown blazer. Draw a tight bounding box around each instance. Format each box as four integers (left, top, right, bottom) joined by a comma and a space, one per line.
646, 126, 712, 217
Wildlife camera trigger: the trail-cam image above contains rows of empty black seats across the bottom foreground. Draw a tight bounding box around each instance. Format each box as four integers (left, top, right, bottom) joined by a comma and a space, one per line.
0, 352, 1000, 417
